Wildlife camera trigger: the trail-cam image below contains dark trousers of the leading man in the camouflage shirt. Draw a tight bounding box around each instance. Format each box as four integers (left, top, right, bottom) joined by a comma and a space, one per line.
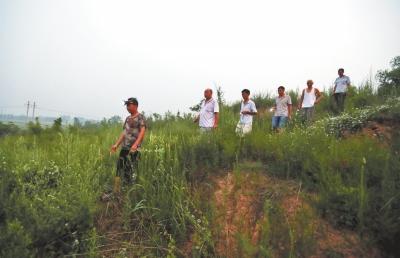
117, 149, 140, 184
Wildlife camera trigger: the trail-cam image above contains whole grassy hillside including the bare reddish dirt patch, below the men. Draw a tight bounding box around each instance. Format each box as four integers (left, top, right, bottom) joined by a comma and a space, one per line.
0, 57, 400, 257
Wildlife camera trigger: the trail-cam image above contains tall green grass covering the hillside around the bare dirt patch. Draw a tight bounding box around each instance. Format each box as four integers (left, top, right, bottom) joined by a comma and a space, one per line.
0, 84, 400, 257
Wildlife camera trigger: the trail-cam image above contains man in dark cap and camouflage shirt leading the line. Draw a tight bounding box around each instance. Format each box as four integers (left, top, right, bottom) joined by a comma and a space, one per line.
111, 98, 146, 184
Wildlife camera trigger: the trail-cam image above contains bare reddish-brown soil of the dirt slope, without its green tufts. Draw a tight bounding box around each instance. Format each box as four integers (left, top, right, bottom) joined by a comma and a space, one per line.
208, 170, 380, 258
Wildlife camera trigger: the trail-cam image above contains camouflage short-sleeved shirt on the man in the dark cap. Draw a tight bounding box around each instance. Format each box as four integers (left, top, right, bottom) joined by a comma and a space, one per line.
122, 114, 146, 150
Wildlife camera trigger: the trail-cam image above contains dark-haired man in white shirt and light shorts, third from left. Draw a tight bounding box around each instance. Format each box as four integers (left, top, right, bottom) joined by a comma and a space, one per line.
236, 89, 257, 136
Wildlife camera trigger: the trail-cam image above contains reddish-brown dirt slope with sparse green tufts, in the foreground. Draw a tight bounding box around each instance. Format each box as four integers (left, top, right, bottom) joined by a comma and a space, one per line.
211, 171, 380, 258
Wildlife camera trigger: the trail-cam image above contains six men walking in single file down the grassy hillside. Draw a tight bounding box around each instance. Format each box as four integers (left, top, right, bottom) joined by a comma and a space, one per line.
111, 68, 350, 183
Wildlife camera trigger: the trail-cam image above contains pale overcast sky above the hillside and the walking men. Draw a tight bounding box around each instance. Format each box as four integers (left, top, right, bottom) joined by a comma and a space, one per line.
0, 0, 400, 118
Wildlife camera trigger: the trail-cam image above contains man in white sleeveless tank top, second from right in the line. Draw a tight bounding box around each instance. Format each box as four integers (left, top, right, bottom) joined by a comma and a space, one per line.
298, 80, 323, 124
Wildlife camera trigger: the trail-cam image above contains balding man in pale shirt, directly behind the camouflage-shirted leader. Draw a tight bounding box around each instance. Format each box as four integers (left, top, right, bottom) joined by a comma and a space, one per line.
195, 88, 219, 132
